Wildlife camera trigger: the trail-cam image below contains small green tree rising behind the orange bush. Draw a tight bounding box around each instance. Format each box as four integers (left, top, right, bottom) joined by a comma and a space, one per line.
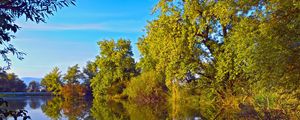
63, 64, 82, 84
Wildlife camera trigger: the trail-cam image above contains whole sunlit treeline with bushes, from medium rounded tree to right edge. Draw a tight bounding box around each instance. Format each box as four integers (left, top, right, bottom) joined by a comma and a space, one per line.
41, 0, 300, 116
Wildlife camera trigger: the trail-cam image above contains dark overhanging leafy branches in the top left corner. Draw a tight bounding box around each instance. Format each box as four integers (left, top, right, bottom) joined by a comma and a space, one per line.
0, 0, 75, 69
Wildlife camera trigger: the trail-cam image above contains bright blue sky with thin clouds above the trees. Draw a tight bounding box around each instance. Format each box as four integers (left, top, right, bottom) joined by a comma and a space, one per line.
9, 0, 157, 77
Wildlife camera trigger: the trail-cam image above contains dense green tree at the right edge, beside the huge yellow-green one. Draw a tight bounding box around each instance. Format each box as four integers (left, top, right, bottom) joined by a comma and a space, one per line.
217, 1, 300, 109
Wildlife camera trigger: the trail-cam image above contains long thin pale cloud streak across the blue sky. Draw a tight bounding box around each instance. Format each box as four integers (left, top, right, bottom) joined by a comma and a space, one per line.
18, 21, 142, 33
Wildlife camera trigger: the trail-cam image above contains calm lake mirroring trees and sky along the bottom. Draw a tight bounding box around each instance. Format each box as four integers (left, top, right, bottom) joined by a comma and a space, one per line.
2, 96, 292, 120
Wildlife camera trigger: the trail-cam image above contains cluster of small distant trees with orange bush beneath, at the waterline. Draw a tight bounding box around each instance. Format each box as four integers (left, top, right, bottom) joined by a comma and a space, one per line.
41, 62, 93, 100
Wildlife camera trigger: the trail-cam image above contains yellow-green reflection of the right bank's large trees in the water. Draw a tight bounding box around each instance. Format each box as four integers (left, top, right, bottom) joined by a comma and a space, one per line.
91, 99, 288, 120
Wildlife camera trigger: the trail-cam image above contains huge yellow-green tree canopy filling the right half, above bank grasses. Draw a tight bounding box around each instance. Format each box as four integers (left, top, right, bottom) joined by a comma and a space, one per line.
138, 0, 299, 101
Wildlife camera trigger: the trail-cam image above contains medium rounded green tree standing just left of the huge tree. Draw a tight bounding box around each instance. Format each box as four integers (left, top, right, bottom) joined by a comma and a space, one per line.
91, 39, 136, 97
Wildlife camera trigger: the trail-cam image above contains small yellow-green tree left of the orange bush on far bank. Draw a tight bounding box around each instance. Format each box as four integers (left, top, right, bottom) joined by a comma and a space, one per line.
41, 67, 62, 95
